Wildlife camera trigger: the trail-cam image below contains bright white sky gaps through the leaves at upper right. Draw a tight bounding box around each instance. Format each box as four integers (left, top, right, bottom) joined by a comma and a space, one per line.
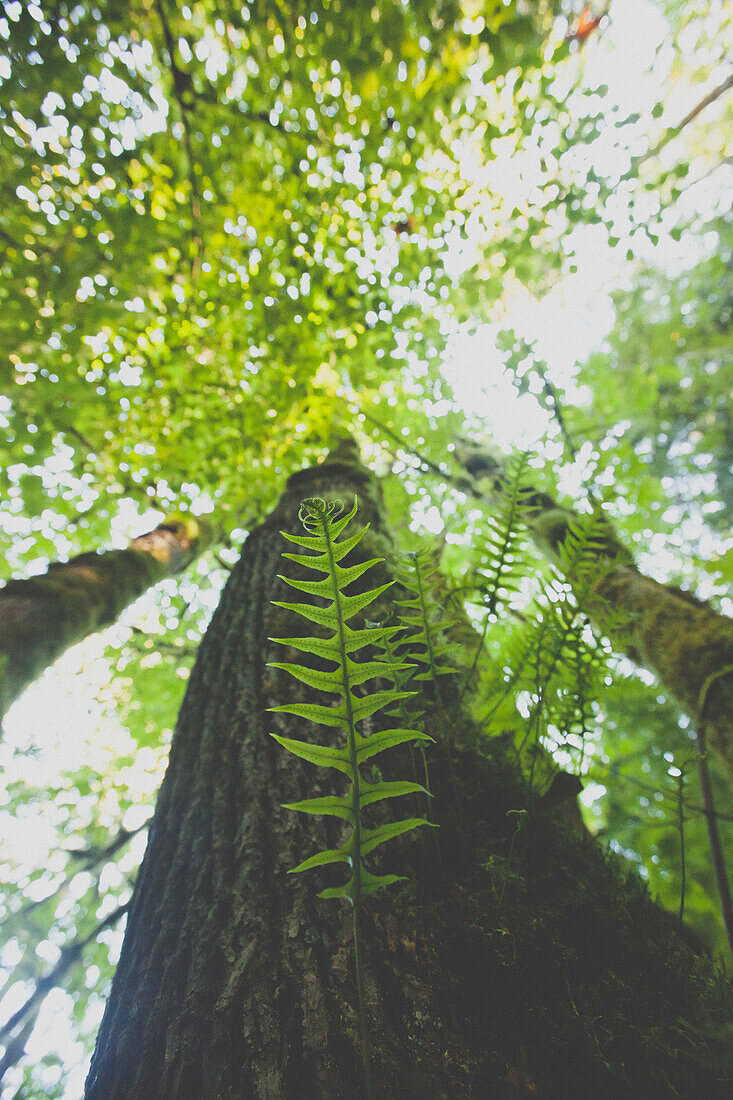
446, 0, 733, 448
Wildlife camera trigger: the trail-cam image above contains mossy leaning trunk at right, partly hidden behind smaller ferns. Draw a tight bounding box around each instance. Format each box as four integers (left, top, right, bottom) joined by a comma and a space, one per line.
459, 440, 733, 777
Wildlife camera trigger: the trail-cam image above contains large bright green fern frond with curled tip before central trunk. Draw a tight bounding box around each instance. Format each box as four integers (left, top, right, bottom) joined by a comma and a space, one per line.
272, 497, 433, 1095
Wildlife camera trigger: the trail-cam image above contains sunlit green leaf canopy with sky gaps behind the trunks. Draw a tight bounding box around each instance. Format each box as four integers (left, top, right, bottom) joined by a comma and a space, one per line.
0, 0, 733, 1098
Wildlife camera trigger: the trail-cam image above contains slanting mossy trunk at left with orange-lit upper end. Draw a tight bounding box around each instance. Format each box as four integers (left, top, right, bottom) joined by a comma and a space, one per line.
0, 517, 214, 718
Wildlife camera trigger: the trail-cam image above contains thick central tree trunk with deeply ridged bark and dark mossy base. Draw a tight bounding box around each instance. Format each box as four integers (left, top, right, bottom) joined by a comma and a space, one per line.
86, 451, 730, 1100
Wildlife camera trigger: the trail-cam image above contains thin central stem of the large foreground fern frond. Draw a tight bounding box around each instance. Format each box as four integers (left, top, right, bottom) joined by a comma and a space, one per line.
322, 510, 372, 1100
